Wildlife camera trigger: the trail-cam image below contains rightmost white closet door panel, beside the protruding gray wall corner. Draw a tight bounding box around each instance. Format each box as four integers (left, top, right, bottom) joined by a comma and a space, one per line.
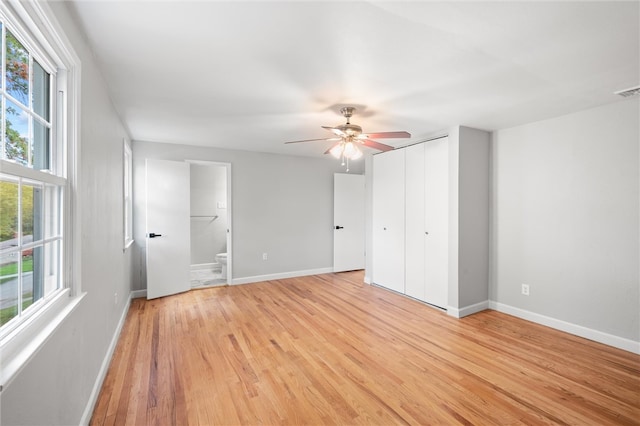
424, 137, 449, 308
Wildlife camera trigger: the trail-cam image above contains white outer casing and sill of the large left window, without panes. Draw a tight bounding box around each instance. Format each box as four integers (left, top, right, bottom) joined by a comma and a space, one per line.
0, 0, 85, 392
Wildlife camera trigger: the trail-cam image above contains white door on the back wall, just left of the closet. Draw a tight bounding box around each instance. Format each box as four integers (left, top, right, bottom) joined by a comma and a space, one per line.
333, 173, 365, 272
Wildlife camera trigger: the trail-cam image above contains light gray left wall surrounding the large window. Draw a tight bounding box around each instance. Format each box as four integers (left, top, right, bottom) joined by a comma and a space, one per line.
0, 2, 131, 425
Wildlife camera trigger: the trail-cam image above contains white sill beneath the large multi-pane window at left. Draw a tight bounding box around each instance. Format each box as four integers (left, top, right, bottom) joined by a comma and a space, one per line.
0, 289, 86, 392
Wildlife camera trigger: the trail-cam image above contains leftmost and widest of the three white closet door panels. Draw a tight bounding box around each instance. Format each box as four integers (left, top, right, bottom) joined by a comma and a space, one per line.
373, 150, 405, 293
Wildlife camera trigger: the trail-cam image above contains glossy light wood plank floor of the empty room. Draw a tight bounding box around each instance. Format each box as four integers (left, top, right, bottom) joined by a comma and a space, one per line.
91, 272, 640, 425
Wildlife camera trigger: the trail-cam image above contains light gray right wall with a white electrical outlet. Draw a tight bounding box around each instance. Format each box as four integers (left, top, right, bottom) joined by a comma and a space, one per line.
490, 98, 640, 342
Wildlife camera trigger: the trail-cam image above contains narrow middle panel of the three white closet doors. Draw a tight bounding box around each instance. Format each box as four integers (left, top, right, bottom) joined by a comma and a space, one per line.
403, 144, 425, 300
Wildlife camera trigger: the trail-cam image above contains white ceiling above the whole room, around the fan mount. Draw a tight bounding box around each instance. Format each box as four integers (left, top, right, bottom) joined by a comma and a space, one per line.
70, 0, 640, 156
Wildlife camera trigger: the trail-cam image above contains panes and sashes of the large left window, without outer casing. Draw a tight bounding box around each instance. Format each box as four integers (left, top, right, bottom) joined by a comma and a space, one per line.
0, 22, 65, 328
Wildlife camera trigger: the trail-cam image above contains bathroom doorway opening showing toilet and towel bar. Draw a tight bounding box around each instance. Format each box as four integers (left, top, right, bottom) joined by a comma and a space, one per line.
187, 160, 232, 288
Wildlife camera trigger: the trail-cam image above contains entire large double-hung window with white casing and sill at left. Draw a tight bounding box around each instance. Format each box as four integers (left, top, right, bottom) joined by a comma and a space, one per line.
0, 2, 82, 390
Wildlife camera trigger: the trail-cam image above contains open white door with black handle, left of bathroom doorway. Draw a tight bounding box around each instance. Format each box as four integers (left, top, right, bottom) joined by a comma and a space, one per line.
146, 159, 191, 299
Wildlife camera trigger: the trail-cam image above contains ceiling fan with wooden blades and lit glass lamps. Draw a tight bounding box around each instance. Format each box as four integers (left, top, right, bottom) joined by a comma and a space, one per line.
285, 106, 411, 165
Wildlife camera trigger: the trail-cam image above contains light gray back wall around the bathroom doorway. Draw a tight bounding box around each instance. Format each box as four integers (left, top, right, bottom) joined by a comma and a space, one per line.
133, 141, 364, 289
